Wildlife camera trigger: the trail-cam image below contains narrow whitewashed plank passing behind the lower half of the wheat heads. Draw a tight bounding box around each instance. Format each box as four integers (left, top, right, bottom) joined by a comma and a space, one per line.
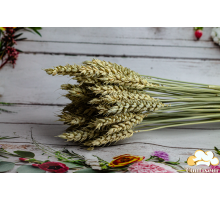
0, 105, 220, 130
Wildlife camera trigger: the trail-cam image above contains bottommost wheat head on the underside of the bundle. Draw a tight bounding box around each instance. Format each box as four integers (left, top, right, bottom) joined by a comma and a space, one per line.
84, 130, 133, 146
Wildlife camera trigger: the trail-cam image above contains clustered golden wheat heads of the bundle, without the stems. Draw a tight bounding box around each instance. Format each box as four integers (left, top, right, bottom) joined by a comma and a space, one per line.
45, 59, 164, 147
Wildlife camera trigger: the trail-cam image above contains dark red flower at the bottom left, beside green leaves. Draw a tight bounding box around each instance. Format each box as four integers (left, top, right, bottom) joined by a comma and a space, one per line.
38, 162, 69, 173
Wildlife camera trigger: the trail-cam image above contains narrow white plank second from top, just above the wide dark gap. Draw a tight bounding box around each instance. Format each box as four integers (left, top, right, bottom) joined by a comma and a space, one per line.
18, 41, 220, 60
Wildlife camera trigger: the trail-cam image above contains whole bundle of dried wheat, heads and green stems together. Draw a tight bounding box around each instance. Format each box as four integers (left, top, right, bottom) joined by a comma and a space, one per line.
45, 59, 220, 149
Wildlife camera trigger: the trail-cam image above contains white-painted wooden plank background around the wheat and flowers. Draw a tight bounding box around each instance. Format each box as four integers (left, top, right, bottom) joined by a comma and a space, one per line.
0, 28, 220, 172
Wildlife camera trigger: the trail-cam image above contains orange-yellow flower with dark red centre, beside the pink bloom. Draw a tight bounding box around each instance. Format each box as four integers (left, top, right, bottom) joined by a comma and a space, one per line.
109, 154, 145, 167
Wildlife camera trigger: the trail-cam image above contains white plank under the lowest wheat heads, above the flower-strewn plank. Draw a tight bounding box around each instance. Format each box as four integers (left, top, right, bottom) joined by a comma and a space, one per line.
0, 124, 220, 148
